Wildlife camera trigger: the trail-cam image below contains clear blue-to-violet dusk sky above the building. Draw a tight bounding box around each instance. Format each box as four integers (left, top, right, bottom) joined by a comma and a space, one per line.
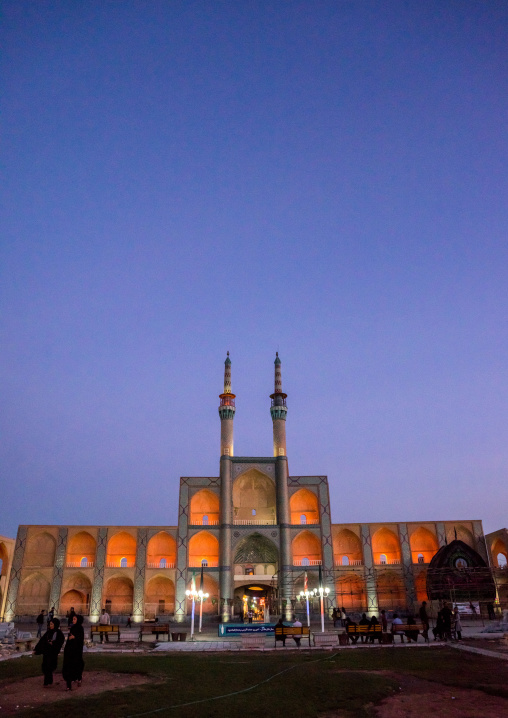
0, 0, 508, 536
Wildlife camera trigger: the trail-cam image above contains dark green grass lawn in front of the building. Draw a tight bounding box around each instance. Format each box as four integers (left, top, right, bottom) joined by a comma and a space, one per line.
0, 647, 508, 718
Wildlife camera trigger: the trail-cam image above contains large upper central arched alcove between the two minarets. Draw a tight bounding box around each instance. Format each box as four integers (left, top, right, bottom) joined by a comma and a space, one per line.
233, 469, 276, 524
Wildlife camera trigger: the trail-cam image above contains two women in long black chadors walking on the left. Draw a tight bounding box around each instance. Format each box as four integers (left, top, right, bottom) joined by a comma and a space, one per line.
34, 615, 85, 691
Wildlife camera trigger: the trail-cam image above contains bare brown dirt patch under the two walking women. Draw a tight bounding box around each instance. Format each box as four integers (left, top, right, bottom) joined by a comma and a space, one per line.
0, 671, 153, 717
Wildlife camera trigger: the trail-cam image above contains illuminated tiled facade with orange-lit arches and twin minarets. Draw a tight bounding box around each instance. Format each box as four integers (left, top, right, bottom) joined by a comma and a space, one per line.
3, 353, 498, 622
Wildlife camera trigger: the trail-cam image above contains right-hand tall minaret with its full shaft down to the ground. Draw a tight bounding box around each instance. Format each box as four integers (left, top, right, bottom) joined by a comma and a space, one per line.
270, 352, 293, 620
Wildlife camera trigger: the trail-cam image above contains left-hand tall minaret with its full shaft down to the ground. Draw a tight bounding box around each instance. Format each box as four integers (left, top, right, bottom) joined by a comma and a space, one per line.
219, 352, 236, 623
